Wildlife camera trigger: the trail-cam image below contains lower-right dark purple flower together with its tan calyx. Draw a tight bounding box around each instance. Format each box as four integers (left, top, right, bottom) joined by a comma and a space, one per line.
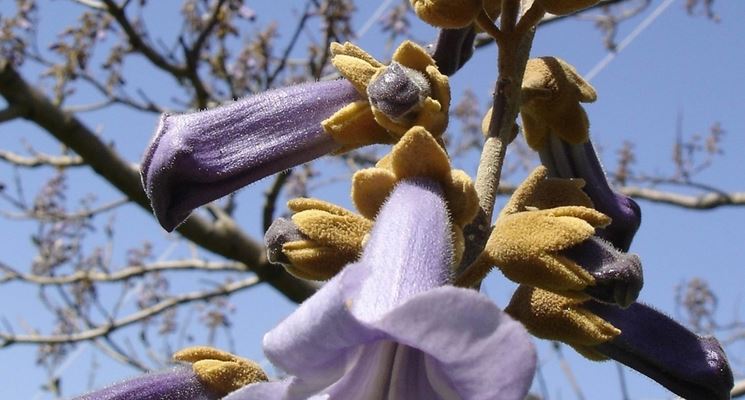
506, 286, 733, 400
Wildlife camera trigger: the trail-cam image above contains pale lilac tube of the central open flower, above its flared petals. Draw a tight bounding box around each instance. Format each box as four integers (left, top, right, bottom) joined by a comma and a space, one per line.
352, 179, 453, 320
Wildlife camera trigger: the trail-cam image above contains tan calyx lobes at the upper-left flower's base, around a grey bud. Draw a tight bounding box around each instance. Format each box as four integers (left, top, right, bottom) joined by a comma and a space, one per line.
321, 41, 450, 147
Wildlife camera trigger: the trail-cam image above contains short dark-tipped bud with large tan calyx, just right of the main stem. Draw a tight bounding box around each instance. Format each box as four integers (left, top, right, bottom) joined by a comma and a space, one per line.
459, 167, 642, 306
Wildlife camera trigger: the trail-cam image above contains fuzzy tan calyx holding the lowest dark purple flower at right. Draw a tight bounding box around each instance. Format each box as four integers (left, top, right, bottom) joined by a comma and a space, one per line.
505, 285, 621, 361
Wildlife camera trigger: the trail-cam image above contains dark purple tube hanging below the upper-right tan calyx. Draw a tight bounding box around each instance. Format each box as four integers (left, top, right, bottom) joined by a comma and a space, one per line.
539, 135, 642, 251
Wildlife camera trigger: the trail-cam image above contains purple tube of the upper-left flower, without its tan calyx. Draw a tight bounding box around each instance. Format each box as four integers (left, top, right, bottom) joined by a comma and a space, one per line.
141, 80, 361, 231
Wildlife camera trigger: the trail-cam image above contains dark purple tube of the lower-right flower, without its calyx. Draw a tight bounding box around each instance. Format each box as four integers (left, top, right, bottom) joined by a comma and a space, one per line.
584, 301, 733, 400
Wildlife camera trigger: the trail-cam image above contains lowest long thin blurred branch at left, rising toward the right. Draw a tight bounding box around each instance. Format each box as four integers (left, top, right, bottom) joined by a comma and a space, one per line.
0, 277, 260, 348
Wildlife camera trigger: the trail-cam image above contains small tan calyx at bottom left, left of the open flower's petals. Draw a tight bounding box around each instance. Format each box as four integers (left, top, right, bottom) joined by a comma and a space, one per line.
173, 346, 268, 395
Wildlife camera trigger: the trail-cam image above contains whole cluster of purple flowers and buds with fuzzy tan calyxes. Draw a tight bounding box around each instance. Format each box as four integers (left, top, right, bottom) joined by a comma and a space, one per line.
77, 14, 732, 400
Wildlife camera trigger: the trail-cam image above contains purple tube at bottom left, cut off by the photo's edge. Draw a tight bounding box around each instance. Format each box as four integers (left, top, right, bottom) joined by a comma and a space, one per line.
73, 366, 222, 400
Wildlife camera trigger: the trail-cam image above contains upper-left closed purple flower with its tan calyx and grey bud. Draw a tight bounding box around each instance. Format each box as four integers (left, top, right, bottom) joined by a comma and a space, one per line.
141, 42, 450, 231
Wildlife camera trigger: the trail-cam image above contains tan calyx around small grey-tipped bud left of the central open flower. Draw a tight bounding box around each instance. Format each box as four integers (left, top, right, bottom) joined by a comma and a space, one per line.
282, 198, 373, 280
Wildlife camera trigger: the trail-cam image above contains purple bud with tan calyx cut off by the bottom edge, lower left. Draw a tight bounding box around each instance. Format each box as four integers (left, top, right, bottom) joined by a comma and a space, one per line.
75, 346, 267, 400
